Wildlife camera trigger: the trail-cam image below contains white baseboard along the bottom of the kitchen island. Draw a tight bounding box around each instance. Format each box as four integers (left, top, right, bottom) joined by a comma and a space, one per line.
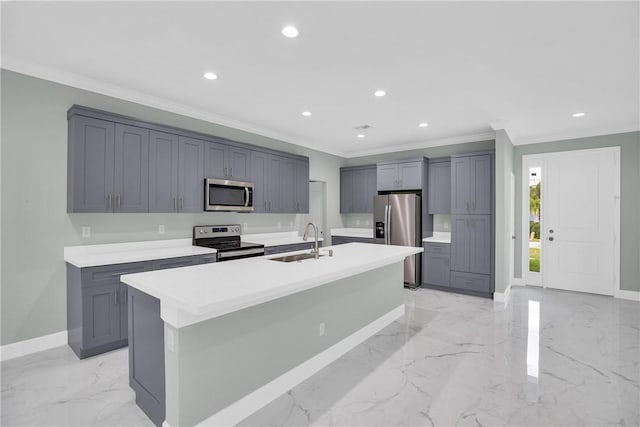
195, 304, 404, 427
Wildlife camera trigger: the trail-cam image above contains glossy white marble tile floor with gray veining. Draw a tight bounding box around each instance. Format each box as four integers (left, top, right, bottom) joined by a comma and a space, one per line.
0, 287, 640, 426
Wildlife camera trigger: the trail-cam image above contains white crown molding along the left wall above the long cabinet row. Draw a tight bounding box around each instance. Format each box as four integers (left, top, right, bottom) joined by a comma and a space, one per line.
2, 54, 344, 157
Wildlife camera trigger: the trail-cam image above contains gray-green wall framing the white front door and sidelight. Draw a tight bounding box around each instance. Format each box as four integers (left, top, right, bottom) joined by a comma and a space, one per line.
513, 132, 640, 291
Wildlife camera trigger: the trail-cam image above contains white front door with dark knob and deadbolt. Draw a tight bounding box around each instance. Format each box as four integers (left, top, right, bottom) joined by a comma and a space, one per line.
540, 148, 619, 295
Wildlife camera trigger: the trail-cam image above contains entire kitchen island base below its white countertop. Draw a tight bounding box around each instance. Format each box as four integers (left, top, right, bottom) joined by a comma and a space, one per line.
129, 262, 404, 427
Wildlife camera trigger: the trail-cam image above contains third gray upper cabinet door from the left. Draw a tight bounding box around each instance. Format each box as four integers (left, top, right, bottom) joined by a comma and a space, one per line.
149, 131, 178, 212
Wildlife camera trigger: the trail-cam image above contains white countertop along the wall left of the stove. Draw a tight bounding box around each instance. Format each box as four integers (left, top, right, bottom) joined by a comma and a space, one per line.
64, 239, 216, 268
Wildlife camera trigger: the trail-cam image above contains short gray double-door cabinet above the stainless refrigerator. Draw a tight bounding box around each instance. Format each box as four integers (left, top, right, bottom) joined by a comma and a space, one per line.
377, 159, 425, 191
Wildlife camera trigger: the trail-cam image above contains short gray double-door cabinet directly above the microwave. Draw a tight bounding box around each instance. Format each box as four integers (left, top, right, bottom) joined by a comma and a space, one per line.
204, 142, 251, 181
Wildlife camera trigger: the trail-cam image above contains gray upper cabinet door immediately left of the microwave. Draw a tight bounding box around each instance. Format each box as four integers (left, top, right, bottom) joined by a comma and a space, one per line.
178, 136, 204, 213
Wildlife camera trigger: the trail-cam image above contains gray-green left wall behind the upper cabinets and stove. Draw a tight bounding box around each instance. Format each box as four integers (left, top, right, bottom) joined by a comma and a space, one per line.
0, 70, 344, 345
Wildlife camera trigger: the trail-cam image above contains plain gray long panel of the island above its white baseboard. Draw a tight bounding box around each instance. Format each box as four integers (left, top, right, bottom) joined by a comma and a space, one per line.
165, 262, 404, 426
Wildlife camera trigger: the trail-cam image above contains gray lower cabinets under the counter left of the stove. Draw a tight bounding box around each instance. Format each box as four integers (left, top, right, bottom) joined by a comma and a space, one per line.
67, 254, 215, 359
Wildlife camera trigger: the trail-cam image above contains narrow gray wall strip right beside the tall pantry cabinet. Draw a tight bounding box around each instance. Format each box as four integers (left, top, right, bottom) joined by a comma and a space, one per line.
495, 130, 514, 292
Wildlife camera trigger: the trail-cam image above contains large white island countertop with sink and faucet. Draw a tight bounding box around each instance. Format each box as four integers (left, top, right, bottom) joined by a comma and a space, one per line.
120, 243, 423, 328
